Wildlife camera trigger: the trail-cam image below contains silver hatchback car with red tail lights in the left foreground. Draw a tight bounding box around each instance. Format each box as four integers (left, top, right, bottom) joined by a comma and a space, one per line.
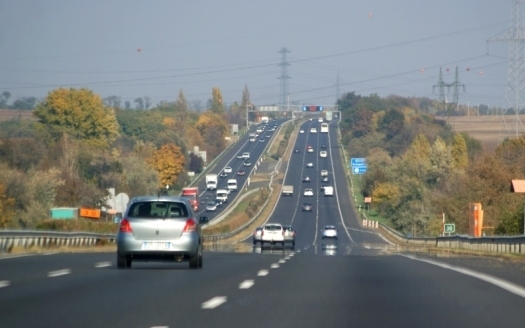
117, 196, 203, 269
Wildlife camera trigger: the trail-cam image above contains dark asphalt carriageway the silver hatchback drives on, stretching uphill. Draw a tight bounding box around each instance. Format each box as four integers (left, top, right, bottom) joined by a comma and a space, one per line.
0, 116, 525, 327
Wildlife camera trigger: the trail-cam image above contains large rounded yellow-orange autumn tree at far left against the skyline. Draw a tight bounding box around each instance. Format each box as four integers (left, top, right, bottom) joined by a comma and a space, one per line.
34, 88, 118, 147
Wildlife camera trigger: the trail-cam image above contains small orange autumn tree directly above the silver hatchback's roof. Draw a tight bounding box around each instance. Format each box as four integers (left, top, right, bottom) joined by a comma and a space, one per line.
148, 144, 186, 188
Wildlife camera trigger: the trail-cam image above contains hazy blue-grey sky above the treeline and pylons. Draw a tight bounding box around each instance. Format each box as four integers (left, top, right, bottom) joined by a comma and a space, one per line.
0, 0, 512, 106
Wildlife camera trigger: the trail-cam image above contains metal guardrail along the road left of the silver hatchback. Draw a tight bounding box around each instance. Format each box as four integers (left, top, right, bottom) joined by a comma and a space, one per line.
0, 230, 116, 253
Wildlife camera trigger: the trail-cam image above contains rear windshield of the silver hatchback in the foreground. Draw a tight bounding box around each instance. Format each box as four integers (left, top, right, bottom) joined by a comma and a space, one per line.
128, 201, 189, 218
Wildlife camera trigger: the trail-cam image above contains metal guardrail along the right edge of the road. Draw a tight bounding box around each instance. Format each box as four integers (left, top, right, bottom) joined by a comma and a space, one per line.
379, 223, 525, 255
